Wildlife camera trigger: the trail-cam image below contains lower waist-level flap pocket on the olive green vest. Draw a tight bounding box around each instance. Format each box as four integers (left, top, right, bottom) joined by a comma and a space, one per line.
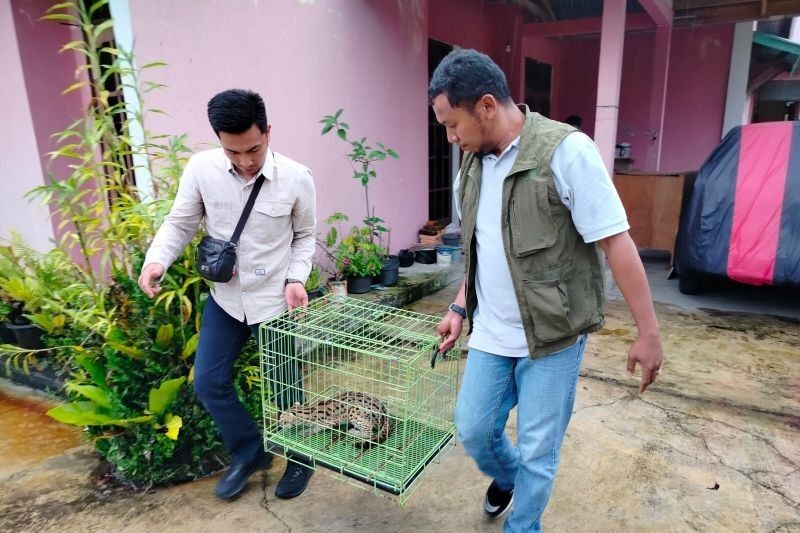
522, 262, 573, 344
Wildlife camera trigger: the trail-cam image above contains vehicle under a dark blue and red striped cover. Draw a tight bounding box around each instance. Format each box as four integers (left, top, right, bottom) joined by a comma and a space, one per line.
675, 121, 800, 294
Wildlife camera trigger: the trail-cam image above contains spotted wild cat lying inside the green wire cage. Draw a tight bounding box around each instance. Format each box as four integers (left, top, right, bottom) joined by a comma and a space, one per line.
278, 391, 392, 448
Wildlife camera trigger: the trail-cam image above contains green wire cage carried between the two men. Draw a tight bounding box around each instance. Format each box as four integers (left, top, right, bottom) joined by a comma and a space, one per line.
259, 295, 461, 505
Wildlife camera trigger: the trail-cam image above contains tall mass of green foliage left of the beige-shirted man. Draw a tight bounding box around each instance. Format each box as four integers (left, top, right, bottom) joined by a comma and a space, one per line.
0, 0, 261, 485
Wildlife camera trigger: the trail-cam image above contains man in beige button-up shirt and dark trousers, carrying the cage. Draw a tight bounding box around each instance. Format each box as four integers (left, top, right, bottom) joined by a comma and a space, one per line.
139, 89, 316, 500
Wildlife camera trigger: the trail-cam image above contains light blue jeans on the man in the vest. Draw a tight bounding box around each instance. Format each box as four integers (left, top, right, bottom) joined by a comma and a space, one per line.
456, 335, 586, 533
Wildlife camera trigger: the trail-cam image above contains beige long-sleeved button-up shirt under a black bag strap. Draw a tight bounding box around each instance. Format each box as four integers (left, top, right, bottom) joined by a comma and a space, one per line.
144, 148, 316, 324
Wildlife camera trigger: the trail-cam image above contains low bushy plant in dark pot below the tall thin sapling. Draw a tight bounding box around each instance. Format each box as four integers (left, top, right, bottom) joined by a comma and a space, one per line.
336, 227, 386, 294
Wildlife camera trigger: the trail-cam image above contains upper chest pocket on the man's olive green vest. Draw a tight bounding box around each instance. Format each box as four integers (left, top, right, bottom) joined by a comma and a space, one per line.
511, 178, 558, 257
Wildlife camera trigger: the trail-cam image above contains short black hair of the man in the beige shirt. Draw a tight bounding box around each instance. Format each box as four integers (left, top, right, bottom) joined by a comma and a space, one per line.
208, 89, 267, 135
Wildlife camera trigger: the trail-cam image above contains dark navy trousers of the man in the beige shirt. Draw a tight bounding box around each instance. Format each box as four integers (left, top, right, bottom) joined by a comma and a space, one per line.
194, 296, 303, 463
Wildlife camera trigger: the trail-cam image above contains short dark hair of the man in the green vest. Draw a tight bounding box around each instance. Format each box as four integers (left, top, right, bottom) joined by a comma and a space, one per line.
428, 50, 511, 107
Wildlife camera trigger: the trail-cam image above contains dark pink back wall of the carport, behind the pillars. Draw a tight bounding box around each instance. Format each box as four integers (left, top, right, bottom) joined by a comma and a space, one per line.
544, 25, 733, 171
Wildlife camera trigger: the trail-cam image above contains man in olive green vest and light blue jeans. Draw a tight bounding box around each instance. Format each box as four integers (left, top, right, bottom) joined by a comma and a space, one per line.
428, 50, 662, 533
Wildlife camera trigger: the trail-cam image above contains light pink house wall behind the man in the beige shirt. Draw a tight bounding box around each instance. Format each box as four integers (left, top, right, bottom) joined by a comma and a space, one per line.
130, 0, 428, 254
